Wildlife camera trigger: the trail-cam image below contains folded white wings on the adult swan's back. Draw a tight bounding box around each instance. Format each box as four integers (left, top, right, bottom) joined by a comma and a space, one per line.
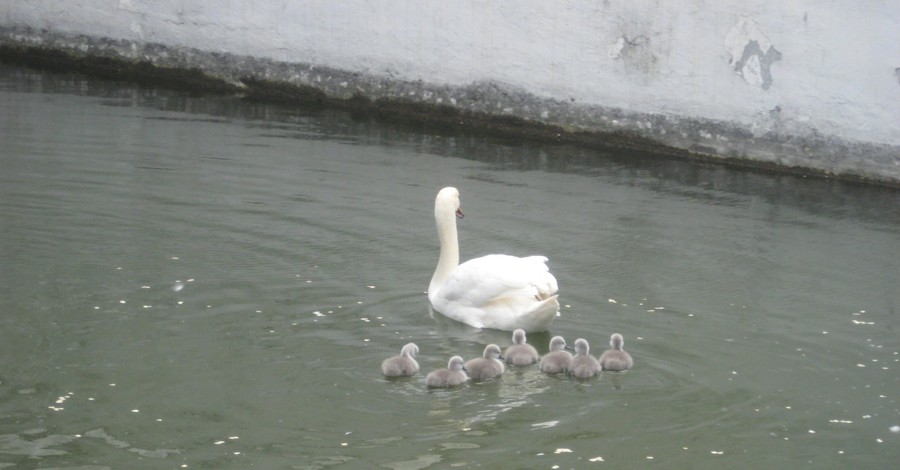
441, 255, 558, 308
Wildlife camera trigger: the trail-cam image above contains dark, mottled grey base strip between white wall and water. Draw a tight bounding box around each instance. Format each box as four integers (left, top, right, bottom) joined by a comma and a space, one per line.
0, 28, 900, 187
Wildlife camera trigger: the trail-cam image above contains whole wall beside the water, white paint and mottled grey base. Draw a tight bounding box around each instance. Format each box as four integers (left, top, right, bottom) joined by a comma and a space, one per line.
0, 0, 900, 182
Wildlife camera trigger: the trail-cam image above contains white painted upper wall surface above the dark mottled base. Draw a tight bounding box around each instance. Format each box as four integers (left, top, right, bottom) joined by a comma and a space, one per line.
0, 0, 900, 179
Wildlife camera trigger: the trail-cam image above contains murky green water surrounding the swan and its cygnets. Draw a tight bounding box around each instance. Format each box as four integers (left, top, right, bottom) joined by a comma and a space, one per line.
0, 68, 900, 469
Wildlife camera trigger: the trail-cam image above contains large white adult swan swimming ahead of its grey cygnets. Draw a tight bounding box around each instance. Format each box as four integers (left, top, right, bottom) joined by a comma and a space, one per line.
428, 187, 559, 333
